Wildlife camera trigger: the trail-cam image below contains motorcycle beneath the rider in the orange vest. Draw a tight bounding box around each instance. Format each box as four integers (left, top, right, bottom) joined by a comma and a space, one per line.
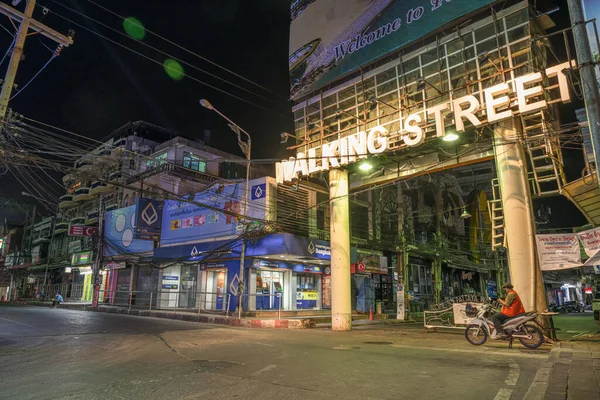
465, 304, 544, 349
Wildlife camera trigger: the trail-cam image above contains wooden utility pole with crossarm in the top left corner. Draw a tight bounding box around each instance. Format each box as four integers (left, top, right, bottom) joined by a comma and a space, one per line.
0, 0, 73, 120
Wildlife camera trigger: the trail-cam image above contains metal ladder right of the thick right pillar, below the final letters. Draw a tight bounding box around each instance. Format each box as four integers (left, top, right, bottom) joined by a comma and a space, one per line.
521, 111, 566, 197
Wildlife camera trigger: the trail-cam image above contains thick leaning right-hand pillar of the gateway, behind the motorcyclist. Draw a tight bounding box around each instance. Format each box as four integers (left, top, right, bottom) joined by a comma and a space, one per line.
494, 119, 547, 312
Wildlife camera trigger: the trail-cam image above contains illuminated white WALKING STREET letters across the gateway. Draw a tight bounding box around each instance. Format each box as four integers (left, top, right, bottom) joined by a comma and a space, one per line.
276, 61, 575, 183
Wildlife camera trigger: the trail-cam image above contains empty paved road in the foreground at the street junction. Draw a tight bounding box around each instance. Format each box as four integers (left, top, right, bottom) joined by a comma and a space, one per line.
0, 306, 549, 400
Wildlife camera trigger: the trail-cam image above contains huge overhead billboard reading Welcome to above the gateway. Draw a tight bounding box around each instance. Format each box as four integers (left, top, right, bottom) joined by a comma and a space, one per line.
289, 0, 496, 98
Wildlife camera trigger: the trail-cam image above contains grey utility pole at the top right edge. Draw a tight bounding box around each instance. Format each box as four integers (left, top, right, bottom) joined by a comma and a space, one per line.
567, 0, 600, 182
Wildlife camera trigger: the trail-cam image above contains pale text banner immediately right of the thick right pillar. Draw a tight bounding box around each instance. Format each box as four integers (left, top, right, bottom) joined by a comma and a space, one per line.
536, 233, 582, 271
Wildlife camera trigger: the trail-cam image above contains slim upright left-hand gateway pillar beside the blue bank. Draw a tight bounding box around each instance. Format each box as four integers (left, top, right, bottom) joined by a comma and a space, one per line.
329, 169, 352, 331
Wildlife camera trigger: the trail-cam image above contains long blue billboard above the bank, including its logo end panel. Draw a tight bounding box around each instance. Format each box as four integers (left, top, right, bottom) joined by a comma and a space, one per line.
160, 178, 268, 246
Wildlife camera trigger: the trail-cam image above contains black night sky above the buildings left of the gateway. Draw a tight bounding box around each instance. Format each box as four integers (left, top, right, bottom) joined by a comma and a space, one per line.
0, 0, 292, 158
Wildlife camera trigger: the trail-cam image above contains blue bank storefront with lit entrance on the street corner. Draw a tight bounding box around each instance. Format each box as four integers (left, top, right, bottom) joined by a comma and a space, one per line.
154, 234, 331, 310
